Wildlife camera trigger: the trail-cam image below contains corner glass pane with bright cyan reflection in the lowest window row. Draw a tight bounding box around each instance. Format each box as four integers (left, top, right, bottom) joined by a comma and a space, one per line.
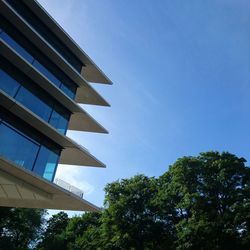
33, 146, 60, 181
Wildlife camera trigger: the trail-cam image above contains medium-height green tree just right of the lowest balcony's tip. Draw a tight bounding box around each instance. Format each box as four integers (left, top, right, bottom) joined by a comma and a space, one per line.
102, 175, 175, 249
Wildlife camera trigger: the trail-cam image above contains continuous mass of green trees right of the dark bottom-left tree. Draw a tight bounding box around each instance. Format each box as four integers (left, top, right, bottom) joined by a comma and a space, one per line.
0, 152, 250, 250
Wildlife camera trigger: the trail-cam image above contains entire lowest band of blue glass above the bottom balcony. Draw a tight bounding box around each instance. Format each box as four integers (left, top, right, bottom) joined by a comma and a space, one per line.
0, 108, 61, 181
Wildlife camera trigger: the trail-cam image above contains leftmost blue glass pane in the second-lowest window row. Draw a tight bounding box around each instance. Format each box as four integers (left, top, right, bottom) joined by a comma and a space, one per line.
0, 69, 20, 97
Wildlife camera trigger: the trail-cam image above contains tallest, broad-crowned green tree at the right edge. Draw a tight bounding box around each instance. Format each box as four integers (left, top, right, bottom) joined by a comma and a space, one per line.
157, 152, 250, 250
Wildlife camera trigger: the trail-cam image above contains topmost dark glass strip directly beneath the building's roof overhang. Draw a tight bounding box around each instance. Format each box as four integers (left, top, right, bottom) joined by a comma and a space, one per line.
4, 0, 83, 73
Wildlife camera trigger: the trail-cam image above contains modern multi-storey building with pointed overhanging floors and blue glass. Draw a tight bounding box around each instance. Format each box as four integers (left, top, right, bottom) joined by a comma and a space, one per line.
0, 0, 111, 211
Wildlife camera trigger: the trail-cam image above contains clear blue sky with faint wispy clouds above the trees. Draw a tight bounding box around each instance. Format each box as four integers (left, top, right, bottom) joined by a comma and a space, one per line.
39, 0, 250, 211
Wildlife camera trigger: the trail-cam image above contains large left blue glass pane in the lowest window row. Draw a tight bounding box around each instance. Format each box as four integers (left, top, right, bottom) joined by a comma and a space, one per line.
0, 123, 39, 170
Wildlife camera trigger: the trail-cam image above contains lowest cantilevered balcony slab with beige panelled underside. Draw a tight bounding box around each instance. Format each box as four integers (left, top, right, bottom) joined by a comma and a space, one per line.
0, 157, 100, 212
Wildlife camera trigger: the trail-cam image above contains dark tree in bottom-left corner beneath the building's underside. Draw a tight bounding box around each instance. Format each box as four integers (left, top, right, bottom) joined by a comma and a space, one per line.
0, 207, 46, 250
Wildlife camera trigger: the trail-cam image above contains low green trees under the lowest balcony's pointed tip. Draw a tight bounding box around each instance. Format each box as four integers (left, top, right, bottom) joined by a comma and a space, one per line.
37, 212, 101, 250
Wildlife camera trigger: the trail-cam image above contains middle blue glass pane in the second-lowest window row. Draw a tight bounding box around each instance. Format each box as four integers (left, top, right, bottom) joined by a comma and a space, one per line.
15, 87, 52, 121
